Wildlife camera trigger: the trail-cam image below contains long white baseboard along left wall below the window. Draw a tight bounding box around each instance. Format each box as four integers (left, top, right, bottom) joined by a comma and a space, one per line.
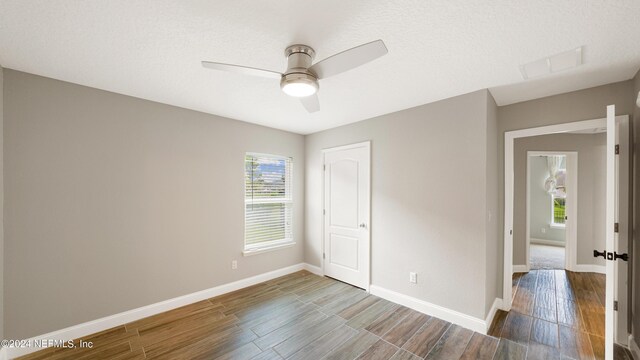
0, 263, 317, 360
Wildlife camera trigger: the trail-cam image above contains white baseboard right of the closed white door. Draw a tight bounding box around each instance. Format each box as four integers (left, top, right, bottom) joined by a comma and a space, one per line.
371, 285, 491, 334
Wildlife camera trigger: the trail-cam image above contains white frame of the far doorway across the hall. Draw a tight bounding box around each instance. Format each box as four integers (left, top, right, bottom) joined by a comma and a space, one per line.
525, 151, 578, 272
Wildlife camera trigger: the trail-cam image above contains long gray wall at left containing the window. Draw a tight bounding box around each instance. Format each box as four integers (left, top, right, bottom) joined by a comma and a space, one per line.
4, 70, 305, 339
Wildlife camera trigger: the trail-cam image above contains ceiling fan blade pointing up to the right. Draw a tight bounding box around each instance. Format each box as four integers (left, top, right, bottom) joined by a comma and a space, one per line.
309, 40, 389, 79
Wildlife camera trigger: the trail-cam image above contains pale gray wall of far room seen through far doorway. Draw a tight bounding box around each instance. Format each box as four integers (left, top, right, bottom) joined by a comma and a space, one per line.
527, 156, 566, 246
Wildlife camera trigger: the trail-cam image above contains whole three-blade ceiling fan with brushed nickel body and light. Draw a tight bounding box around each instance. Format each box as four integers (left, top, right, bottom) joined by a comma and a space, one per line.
202, 40, 388, 113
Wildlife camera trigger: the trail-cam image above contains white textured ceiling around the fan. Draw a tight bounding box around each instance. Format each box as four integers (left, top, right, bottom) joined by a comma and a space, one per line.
0, 0, 640, 134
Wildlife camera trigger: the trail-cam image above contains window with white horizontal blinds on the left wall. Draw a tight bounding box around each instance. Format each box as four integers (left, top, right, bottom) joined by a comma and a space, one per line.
244, 154, 293, 254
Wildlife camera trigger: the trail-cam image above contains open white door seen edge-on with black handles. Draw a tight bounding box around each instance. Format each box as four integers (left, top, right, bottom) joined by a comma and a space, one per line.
605, 105, 618, 360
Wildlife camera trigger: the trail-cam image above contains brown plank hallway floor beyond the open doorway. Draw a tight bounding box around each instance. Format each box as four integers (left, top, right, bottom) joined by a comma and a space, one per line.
489, 270, 631, 360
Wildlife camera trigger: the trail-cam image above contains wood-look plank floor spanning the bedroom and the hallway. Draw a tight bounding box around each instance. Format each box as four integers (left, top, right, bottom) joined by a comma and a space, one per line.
15, 271, 632, 360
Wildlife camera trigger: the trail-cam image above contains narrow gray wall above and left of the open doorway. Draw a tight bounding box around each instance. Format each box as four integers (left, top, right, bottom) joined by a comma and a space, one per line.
497, 80, 635, 297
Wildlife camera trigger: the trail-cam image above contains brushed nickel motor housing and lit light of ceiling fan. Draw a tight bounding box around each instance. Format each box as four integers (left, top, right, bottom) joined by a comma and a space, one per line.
280, 45, 319, 96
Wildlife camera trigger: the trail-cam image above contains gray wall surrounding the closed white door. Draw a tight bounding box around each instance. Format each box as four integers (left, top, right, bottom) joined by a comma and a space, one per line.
305, 90, 493, 319
